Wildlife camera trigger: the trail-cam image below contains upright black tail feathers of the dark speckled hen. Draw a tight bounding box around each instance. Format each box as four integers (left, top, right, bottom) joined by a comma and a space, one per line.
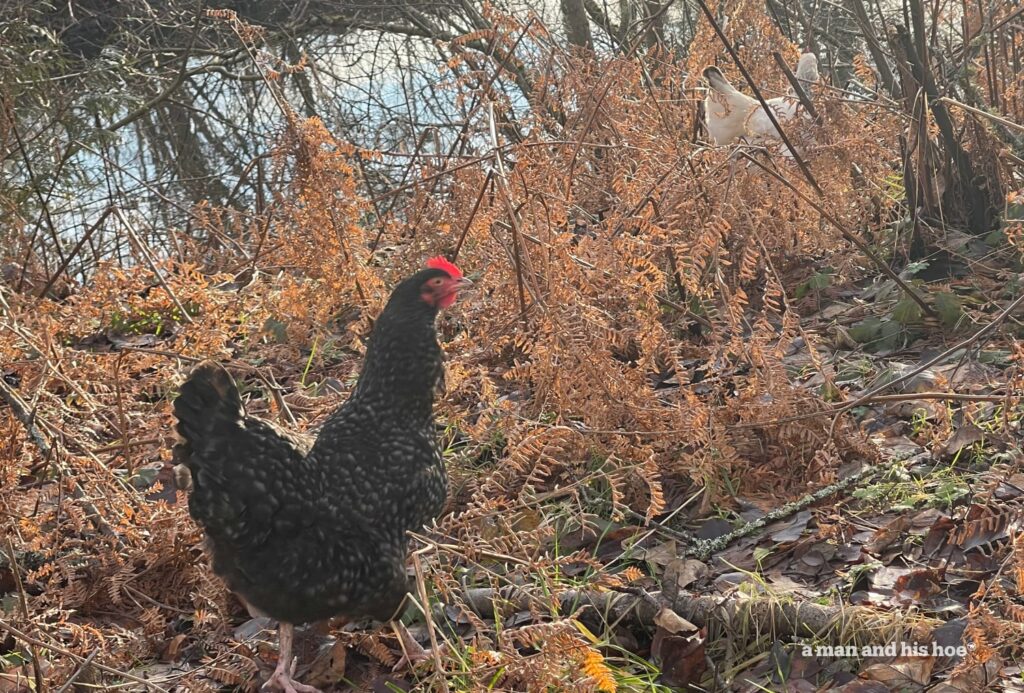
174, 361, 245, 487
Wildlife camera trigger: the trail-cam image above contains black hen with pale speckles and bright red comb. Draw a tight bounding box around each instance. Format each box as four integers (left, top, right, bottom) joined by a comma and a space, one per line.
174, 258, 470, 693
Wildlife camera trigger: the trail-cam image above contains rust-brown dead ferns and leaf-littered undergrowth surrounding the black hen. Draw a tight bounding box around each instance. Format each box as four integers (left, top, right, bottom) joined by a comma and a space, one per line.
0, 3, 1024, 691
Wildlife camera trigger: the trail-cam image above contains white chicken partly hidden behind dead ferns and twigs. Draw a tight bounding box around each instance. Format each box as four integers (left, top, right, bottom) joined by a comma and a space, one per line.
703, 53, 818, 150
